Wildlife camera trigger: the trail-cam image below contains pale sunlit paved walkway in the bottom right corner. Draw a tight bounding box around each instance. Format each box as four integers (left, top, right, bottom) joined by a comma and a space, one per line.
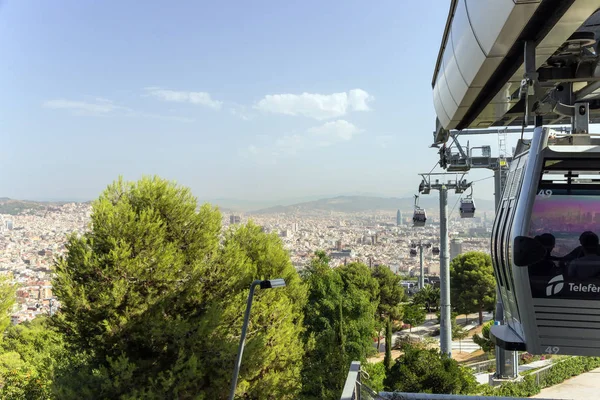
533, 368, 600, 400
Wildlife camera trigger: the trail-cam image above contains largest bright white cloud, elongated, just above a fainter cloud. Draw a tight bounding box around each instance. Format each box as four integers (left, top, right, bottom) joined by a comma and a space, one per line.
254, 89, 373, 120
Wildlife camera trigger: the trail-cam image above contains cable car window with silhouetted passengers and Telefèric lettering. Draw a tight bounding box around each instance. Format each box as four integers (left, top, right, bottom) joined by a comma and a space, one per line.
528, 159, 600, 300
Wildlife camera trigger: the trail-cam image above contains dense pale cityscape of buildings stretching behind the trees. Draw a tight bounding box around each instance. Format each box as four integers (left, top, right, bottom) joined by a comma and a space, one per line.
0, 197, 493, 324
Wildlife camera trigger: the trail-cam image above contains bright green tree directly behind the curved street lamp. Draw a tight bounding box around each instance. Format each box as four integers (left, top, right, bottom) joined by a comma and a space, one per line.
213, 223, 307, 399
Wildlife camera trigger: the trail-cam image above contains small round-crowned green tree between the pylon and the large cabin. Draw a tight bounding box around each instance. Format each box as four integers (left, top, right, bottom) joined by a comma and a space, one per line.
450, 251, 496, 325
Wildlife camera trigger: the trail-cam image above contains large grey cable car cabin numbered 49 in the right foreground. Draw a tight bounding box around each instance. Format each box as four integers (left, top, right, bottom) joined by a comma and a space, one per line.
491, 127, 600, 356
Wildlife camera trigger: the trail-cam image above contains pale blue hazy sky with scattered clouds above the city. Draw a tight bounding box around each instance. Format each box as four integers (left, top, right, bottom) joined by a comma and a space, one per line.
0, 0, 514, 200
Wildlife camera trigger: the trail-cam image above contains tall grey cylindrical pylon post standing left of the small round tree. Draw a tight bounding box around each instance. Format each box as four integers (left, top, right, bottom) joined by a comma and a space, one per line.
440, 185, 452, 356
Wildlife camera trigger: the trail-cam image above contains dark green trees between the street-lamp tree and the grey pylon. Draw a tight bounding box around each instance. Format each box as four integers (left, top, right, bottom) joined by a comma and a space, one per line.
302, 252, 378, 399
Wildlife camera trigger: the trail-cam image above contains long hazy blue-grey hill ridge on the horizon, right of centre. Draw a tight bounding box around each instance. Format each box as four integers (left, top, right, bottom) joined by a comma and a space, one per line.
250, 195, 494, 214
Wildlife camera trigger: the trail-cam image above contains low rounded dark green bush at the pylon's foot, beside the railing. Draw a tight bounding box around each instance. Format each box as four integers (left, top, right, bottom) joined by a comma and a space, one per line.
385, 345, 477, 394
